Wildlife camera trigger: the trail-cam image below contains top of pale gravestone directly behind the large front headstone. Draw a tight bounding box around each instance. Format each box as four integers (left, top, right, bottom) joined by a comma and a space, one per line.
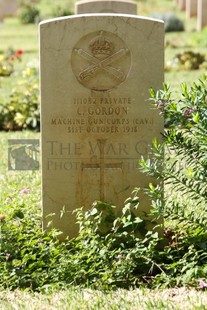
75, 0, 137, 15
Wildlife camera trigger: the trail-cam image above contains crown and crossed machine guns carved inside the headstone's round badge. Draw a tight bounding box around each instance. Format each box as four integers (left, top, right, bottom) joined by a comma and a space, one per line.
74, 32, 129, 88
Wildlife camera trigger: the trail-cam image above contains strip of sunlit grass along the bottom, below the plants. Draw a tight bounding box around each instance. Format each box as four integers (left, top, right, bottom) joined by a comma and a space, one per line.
0, 288, 207, 310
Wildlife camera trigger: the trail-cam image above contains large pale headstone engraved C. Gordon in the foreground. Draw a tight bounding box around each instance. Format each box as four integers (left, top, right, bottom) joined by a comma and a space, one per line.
40, 14, 164, 239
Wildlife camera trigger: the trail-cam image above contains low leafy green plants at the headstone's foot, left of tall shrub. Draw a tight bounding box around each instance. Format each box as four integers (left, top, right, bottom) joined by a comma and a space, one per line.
0, 191, 160, 290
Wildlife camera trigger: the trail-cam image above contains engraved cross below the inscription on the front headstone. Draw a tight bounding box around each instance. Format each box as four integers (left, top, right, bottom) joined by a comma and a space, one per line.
81, 139, 123, 201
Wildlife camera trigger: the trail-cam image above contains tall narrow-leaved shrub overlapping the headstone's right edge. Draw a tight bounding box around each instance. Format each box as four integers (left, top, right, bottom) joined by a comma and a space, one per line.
141, 76, 207, 285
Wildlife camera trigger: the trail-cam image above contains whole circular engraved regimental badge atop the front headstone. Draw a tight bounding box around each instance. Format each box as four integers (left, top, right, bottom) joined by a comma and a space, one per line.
71, 31, 131, 91
